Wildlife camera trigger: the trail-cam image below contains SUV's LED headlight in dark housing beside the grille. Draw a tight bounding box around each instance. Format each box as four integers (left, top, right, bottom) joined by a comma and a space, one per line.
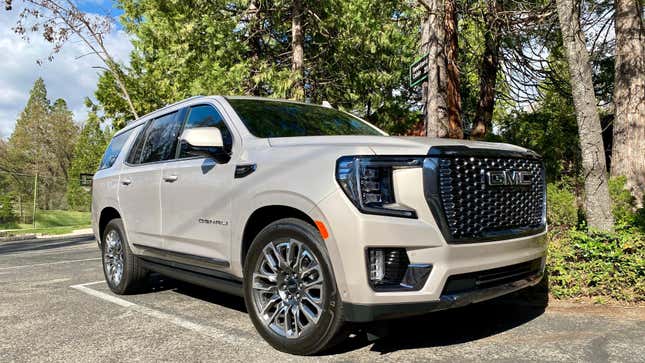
336, 156, 423, 218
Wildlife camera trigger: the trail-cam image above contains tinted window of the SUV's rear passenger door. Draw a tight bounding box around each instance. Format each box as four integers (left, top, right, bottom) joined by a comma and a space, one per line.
140, 112, 181, 164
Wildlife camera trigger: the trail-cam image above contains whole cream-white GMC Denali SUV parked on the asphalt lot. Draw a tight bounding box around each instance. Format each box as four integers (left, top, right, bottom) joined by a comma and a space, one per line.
92, 96, 546, 354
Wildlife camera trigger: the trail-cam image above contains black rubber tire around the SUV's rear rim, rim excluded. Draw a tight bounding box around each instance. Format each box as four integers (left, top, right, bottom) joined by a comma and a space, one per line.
101, 218, 148, 295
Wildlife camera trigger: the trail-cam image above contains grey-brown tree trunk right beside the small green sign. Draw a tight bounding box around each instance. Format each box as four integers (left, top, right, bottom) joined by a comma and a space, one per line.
421, 0, 448, 137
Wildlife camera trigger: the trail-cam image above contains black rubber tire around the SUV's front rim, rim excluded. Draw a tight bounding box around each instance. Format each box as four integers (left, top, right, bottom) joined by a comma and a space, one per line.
244, 218, 344, 355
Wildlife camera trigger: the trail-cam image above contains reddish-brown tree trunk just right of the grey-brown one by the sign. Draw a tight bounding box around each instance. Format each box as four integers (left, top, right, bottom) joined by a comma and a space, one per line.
444, 0, 464, 139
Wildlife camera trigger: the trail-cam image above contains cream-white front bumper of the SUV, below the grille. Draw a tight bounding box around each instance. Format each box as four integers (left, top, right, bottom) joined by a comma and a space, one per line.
309, 168, 547, 321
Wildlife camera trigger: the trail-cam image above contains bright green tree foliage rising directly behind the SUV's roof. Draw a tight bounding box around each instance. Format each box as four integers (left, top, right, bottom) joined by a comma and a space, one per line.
96, 0, 420, 133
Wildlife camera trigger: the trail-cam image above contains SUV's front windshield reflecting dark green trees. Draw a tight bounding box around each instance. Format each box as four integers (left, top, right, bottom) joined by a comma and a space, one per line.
228, 99, 383, 138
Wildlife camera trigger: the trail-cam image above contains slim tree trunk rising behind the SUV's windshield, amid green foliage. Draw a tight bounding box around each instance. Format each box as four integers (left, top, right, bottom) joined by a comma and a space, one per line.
291, 0, 305, 101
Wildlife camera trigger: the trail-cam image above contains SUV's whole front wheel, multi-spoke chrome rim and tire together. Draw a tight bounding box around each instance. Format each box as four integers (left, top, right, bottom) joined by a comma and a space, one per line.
244, 218, 343, 355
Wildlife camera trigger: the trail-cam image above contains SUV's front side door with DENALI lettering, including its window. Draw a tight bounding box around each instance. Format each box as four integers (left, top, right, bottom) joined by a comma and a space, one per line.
161, 104, 235, 267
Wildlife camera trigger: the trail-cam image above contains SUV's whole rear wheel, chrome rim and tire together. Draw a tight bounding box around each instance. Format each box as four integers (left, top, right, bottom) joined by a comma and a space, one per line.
101, 218, 147, 295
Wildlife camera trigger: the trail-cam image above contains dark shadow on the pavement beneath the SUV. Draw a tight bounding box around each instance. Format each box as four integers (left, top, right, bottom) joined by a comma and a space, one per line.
142, 274, 548, 355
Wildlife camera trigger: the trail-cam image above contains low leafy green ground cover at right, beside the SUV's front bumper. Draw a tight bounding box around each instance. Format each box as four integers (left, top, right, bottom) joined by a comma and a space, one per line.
547, 229, 645, 302
